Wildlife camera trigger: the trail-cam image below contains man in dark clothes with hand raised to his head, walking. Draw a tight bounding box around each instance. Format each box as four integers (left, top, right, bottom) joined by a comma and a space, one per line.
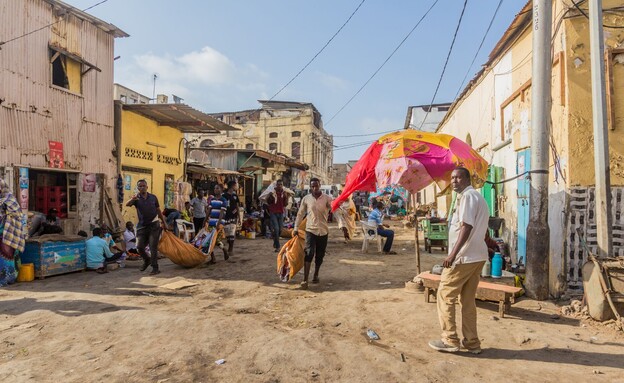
126, 180, 167, 275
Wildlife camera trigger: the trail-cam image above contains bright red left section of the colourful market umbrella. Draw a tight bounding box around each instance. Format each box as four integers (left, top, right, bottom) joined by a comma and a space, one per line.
332, 141, 383, 211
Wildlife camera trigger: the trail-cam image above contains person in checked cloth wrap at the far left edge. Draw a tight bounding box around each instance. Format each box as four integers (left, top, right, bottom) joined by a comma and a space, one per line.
0, 178, 27, 286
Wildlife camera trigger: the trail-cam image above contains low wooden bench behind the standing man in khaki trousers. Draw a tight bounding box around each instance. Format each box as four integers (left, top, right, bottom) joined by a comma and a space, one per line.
418, 272, 522, 318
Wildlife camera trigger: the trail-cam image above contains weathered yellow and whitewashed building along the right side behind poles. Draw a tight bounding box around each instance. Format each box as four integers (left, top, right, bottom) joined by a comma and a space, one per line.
421, 0, 624, 296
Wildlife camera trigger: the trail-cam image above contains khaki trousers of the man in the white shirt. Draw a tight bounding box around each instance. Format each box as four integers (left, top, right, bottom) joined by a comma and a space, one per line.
437, 262, 485, 349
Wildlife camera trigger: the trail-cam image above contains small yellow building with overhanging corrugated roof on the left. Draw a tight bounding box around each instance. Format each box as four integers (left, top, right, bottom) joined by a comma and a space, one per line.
115, 101, 233, 222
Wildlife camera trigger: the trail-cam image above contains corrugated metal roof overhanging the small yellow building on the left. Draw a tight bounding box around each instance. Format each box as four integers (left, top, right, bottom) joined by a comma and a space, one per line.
123, 104, 240, 133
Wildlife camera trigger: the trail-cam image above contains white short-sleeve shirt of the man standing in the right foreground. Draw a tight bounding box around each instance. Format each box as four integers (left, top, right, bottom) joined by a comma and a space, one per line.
449, 186, 490, 264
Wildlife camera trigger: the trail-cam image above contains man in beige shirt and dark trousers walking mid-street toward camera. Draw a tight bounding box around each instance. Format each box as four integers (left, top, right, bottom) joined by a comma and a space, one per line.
293, 178, 332, 290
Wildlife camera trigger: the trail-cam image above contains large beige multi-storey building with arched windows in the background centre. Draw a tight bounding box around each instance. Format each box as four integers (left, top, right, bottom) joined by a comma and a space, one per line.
187, 100, 333, 183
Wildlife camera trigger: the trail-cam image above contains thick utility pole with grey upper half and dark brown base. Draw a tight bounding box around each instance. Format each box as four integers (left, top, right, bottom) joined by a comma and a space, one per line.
526, 0, 552, 300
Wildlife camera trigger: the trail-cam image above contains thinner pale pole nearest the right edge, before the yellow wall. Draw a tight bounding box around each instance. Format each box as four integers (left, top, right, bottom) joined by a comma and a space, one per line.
589, 0, 613, 257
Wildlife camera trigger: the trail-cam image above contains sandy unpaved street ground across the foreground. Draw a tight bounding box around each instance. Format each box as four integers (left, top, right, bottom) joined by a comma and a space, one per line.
0, 223, 624, 383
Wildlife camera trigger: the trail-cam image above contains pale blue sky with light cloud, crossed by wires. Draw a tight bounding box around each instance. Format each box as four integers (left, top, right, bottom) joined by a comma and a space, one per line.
65, 0, 526, 163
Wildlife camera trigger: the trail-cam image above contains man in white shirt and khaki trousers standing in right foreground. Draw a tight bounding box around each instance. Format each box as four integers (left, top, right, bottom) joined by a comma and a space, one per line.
429, 167, 489, 354
